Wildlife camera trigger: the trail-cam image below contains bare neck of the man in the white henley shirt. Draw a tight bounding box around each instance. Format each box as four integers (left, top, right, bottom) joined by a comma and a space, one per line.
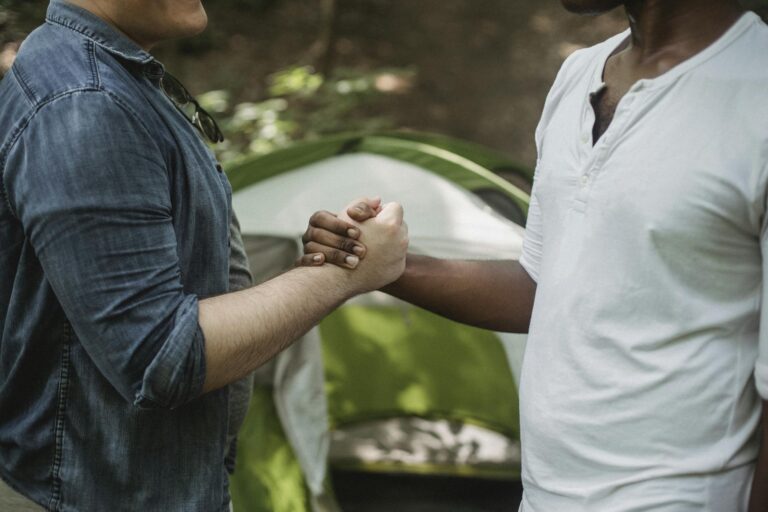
624, 0, 744, 61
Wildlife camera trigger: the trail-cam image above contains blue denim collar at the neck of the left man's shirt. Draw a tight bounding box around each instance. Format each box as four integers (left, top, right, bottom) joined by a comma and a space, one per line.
46, 0, 159, 68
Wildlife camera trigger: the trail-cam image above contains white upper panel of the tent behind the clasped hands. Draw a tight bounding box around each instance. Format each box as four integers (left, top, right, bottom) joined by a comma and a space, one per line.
233, 154, 523, 259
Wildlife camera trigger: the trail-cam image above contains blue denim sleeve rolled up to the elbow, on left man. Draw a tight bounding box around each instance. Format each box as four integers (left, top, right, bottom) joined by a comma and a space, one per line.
3, 91, 205, 408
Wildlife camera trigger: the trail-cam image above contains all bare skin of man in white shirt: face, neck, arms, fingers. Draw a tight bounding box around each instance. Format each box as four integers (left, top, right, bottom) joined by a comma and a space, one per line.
301, 0, 768, 506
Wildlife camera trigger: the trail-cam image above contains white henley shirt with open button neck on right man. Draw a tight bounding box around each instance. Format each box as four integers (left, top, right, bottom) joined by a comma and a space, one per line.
520, 13, 768, 512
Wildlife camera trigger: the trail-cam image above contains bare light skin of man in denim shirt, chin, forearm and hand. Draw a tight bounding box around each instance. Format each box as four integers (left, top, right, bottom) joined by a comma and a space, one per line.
70, 0, 408, 392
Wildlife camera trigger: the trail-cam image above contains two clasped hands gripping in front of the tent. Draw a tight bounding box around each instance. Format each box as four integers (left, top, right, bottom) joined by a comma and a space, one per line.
297, 198, 408, 294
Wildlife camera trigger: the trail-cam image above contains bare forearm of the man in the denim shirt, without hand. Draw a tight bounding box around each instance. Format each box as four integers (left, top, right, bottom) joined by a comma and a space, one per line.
199, 265, 353, 392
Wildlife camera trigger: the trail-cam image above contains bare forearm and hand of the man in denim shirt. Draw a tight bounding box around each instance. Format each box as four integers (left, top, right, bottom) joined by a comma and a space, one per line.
200, 203, 408, 391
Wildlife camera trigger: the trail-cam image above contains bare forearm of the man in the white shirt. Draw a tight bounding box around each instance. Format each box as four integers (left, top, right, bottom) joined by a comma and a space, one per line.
383, 254, 536, 333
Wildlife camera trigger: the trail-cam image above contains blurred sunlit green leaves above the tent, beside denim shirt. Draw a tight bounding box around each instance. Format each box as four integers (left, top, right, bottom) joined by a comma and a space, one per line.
198, 65, 415, 162
